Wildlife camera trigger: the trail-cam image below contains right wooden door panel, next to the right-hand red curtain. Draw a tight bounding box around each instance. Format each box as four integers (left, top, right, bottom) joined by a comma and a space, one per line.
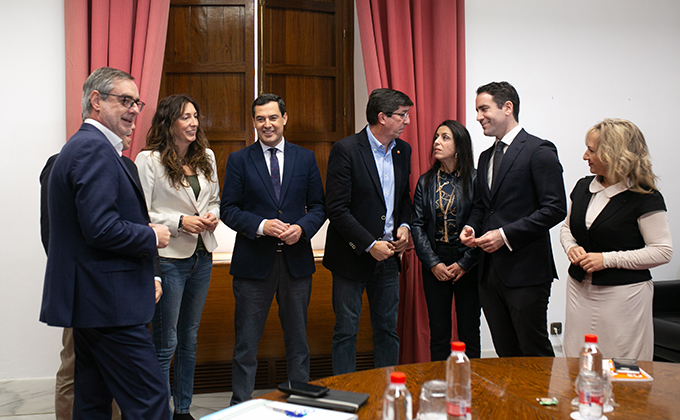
260, 0, 354, 185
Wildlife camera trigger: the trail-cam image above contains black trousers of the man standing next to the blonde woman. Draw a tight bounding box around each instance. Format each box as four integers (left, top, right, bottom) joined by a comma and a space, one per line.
479, 255, 555, 357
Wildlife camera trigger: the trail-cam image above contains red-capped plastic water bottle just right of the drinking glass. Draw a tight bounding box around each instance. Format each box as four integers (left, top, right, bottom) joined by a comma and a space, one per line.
446, 341, 472, 420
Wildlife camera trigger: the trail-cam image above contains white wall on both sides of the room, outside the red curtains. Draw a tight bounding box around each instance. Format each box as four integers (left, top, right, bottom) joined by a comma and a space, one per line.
0, 0, 680, 380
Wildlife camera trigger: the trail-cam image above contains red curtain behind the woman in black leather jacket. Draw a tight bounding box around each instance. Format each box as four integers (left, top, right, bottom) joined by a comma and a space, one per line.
356, 0, 465, 363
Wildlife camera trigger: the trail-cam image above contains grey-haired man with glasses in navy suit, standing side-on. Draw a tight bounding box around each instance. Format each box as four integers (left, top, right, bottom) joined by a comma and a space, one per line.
40, 67, 170, 420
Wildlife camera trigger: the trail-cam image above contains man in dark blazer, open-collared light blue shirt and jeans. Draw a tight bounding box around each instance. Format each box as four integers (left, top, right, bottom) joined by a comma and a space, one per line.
323, 89, 413, 375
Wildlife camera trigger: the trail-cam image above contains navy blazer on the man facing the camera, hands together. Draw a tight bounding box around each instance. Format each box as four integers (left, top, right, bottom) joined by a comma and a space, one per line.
220, 142, 326, 279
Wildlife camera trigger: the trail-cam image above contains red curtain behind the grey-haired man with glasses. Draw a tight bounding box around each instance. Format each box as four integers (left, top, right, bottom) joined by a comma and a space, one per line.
64, 0, 170, 159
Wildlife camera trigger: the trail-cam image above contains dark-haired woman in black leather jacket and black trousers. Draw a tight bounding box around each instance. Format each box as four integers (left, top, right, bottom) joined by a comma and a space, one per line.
411, 120, 480, 361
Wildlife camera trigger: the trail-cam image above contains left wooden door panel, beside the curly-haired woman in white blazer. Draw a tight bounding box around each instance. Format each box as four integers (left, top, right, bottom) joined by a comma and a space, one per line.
160, 0, 255, 186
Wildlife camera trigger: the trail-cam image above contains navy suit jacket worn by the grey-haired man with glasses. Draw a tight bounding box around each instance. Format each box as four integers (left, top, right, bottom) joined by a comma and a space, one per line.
40, 124, 156, 328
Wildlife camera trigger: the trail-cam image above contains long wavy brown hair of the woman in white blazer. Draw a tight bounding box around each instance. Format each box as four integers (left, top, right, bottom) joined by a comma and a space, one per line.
144, 94, 213, 189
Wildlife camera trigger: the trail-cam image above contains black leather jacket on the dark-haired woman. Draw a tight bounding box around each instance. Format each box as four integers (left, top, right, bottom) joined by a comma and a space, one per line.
411, 169, 480, 271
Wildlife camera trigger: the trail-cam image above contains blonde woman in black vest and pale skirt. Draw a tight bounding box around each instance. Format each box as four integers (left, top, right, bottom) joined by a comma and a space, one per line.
560, 119, 673, 360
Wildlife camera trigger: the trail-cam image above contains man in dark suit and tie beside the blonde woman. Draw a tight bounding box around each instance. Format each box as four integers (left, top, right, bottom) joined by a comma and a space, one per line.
460, 82, 567, 357
